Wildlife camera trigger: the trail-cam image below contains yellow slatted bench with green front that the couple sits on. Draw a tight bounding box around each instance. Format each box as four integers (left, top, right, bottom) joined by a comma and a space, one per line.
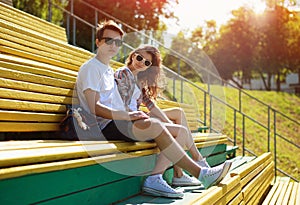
0, 3, 232, 204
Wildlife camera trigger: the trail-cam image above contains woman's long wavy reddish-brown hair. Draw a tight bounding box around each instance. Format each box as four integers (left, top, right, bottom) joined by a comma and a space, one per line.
126, 45, 162, 99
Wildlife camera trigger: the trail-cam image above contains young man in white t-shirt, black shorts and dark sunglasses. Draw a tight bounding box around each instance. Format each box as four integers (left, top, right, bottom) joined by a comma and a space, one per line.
76, 21, 231, 198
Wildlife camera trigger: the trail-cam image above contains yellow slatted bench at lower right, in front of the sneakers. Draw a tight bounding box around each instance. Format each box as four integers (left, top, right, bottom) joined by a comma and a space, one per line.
117, 153, 276, 205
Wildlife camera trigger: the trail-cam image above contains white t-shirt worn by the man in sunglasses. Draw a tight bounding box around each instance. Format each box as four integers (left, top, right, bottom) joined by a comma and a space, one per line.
76, 57, 126, 129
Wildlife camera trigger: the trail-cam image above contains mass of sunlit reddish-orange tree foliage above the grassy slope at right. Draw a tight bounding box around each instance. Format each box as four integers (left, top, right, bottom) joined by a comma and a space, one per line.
191, 1, 300, 91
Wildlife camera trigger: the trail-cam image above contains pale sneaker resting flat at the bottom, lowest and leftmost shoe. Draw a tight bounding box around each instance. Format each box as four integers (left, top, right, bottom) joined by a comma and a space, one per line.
143, 174, 183, 198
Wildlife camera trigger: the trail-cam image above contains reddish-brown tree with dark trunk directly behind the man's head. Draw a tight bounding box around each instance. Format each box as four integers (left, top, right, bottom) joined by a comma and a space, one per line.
67, 0, 177, 50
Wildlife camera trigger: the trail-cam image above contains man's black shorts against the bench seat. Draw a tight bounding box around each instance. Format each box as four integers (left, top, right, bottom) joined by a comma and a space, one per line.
102, 120, 138, 142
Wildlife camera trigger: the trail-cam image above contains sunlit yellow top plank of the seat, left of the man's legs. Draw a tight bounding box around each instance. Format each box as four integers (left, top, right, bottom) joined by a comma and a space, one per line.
0, 143, 156, 167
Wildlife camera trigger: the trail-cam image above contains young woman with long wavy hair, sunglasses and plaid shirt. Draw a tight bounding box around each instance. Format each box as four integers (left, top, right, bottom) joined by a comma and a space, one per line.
115, 45, 220, 197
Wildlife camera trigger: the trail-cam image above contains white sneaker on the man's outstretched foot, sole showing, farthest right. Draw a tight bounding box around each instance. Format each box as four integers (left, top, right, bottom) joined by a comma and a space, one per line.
198, 161, 232, 189
